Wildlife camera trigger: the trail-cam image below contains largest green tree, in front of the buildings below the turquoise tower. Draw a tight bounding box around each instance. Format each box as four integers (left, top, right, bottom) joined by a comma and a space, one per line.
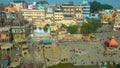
81, 19, 101, 35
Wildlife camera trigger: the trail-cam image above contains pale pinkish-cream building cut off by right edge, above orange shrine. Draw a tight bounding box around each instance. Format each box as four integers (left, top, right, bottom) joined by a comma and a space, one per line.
113, 9, 120, 31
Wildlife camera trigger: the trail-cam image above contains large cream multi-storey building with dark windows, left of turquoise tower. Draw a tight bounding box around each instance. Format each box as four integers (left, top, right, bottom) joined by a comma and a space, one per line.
54, 3, 82, 25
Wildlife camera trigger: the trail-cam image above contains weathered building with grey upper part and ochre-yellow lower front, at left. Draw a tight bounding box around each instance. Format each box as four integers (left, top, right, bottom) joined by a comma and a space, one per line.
11, 17, 30, 43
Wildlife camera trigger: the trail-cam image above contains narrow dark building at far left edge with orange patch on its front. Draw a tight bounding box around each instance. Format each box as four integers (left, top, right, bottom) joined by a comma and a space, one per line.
0, 12, 12, 45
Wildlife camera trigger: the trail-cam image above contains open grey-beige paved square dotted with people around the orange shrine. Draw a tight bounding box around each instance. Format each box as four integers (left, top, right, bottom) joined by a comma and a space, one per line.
55, 28, 120, 65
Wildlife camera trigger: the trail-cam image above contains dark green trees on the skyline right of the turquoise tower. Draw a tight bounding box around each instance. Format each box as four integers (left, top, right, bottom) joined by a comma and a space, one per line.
90, 1, 113, 13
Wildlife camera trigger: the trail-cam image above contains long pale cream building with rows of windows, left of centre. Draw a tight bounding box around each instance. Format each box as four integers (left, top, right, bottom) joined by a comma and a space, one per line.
21, 9, 45, 27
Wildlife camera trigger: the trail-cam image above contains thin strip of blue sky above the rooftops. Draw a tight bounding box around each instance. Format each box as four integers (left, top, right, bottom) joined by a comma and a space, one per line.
0, 0, 120, 8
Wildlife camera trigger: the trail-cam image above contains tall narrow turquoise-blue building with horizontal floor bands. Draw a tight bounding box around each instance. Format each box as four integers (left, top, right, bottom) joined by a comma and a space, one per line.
82, 0, 90, 19
